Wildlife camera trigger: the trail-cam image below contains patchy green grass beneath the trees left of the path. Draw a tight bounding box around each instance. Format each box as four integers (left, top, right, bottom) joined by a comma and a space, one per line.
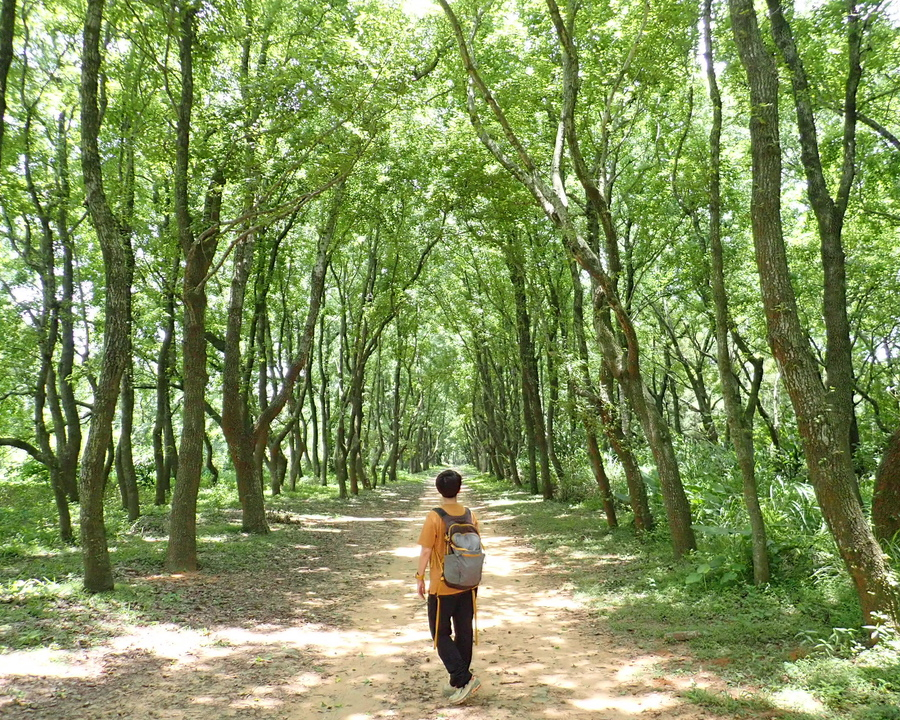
0, 476, 421, 653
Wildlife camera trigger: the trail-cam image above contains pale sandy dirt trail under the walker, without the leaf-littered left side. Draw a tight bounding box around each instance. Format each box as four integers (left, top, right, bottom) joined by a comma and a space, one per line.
292, 480, 713, 720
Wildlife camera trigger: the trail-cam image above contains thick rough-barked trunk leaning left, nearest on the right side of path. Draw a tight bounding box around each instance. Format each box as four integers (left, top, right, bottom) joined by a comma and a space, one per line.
729, 0, 900, 624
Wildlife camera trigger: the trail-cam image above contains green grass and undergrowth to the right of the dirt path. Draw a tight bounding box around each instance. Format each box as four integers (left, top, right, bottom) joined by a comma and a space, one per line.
467, 476, 900, 720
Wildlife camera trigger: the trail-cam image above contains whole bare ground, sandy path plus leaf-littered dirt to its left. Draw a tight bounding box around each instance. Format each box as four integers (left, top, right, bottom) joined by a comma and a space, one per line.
0, 480, 752, 720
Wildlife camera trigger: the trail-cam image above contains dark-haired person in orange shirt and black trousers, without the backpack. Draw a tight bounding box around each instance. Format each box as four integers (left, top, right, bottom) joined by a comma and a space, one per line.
416, 470, 481, 705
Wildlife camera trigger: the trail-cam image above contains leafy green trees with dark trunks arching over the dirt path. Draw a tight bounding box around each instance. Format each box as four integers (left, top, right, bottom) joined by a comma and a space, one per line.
0, 0, 900, 624
